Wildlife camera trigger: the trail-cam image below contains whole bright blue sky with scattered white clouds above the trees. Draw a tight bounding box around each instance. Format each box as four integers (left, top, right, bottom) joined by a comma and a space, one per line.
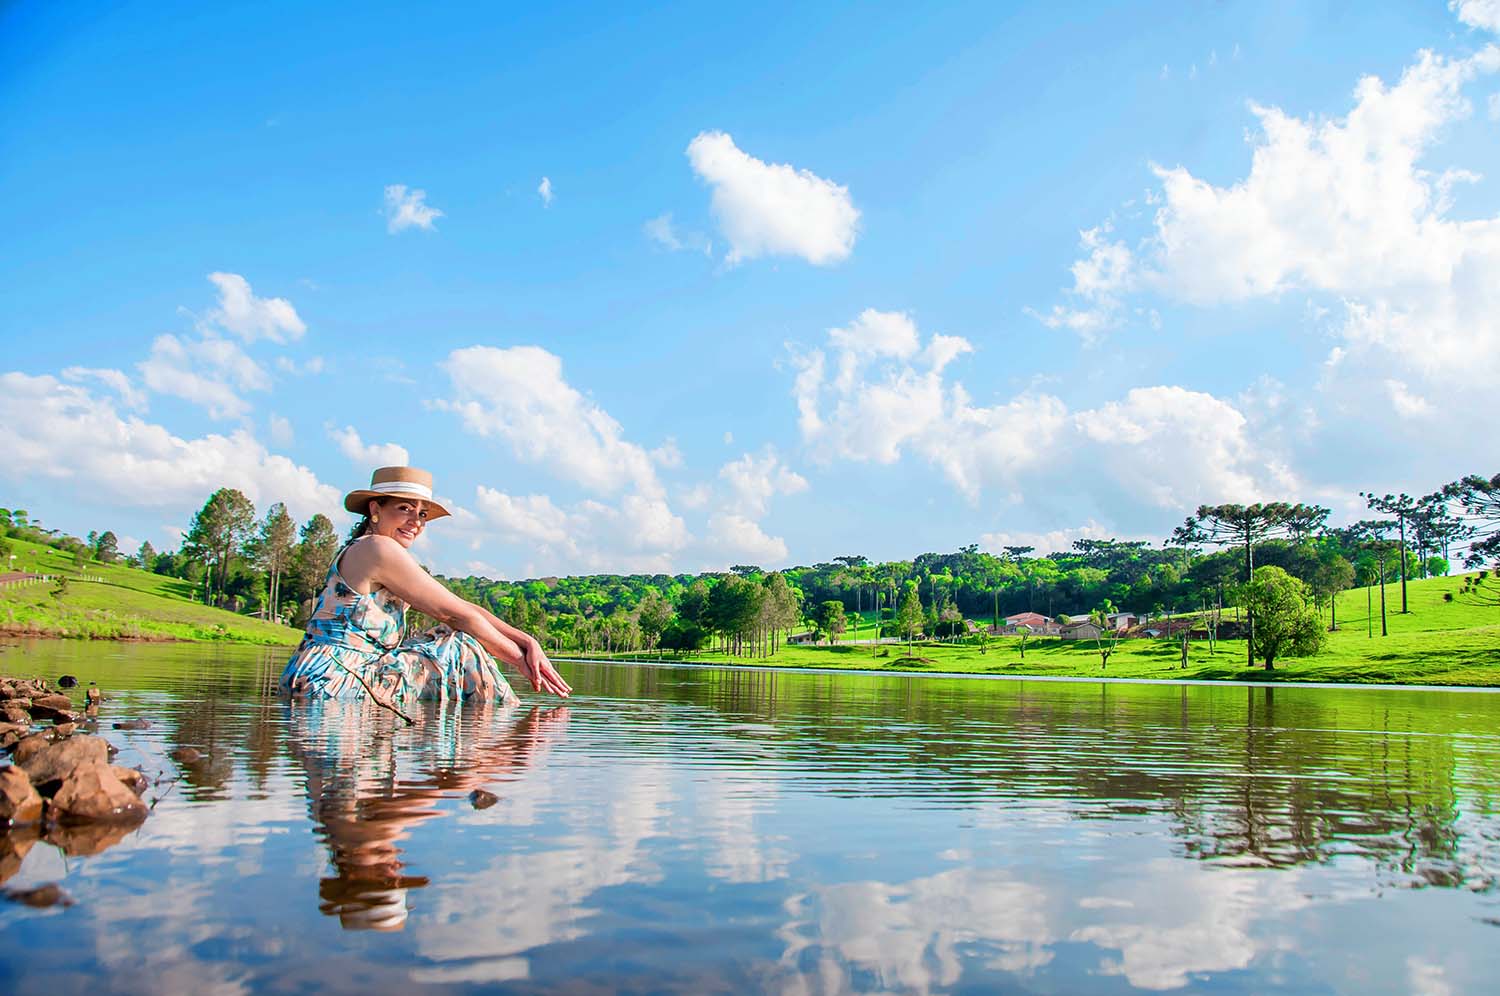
0, 0, 1500, 578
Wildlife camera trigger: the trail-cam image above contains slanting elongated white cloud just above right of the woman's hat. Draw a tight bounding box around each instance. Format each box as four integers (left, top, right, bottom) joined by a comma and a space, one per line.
434, 347, 663, 497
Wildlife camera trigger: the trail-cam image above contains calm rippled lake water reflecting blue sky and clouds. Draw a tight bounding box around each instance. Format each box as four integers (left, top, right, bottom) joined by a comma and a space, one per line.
0, 642, 1500, 993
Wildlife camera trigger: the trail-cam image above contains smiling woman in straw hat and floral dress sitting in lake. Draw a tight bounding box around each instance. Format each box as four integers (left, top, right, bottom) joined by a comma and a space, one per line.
281, 467, 572, 707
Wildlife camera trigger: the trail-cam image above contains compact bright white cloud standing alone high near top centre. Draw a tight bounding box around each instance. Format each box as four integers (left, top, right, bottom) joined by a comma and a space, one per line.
687, 132, 860, 266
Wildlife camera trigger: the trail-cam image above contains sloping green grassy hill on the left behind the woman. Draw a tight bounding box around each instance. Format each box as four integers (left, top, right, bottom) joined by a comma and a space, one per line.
0, 539, 302, 645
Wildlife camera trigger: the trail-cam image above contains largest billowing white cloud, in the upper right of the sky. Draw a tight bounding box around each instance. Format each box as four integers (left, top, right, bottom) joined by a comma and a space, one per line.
1038, 35, 1500, 380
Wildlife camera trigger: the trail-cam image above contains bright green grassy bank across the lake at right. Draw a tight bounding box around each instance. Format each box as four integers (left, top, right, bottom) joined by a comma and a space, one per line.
573, 576, 1500, 687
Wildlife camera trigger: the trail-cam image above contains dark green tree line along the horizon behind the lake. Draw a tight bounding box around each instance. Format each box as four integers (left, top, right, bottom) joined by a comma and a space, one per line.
0, 474, 1500, 657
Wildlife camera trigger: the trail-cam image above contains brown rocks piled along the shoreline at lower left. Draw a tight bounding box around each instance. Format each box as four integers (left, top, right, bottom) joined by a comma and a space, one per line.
0, 677, 162, 906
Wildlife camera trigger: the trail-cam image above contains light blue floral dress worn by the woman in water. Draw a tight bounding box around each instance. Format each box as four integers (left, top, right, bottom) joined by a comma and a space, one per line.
281, 548, 519, 705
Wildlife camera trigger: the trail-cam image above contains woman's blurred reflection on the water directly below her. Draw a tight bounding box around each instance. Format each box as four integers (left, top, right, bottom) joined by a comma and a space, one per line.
290, 701, 569, 930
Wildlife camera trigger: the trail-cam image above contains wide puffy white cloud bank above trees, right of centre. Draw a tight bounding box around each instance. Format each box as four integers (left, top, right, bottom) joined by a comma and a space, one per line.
792, 312, 1296, 510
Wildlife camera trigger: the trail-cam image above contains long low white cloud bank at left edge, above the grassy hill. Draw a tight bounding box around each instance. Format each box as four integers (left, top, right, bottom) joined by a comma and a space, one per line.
0, 372, 341, 518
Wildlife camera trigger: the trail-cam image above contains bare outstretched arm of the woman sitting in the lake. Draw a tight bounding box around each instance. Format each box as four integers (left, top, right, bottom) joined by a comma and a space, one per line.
354, 536, 573, 696
